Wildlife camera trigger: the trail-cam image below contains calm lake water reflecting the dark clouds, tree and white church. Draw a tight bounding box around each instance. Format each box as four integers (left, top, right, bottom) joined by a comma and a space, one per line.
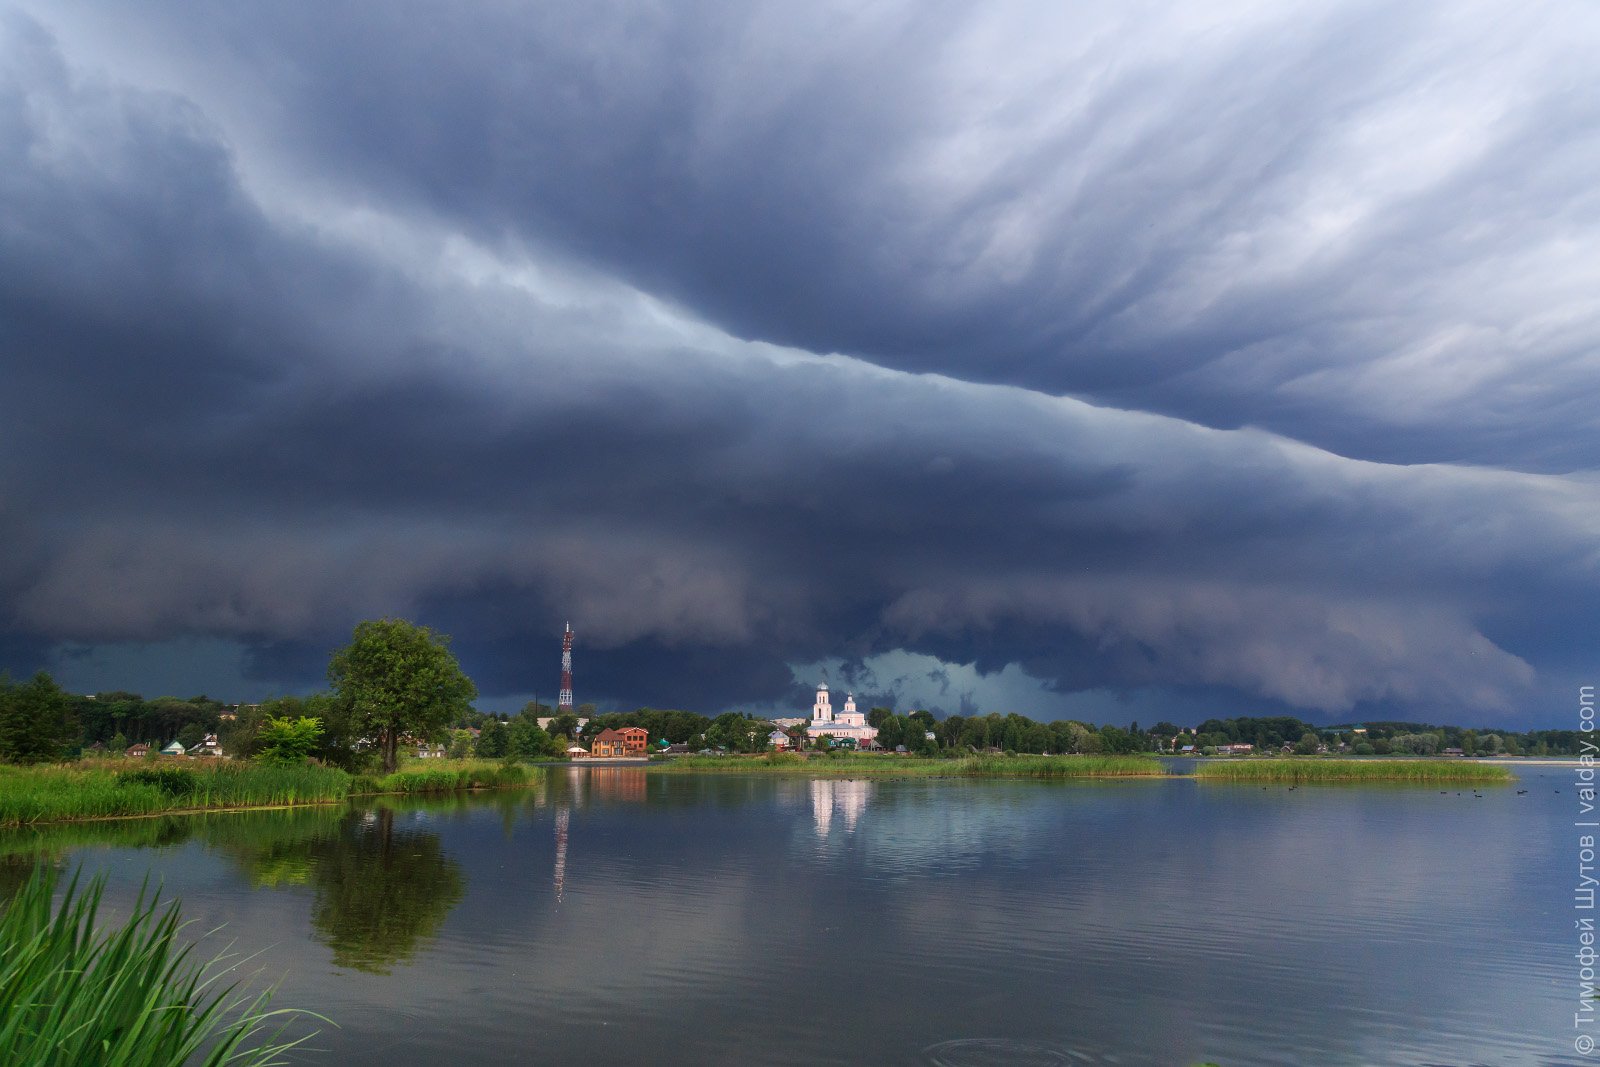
3, 766, 1574, 1067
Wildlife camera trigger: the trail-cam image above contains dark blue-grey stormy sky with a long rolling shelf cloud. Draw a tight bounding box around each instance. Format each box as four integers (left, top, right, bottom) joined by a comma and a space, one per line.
0, 0, 1600, 726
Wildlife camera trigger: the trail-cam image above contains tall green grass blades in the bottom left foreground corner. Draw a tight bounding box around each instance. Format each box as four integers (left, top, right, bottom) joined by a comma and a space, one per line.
0, 867, 325, 1067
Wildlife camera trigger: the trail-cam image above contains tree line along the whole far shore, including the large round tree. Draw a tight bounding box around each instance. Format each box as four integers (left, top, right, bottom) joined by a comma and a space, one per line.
0, 619, 1584, 771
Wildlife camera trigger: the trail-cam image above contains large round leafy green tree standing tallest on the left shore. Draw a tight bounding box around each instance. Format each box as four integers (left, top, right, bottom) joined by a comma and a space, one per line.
328, 619, 478, 773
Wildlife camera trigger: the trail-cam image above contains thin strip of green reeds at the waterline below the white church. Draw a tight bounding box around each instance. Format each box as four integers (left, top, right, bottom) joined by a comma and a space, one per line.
650, 752, 1166, 777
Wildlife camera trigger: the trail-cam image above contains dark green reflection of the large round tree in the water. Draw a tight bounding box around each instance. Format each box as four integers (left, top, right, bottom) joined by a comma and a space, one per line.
310, 808, 466, 974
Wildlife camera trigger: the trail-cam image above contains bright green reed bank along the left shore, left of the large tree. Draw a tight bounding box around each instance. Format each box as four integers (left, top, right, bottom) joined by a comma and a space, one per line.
0, 761, 350, 827
